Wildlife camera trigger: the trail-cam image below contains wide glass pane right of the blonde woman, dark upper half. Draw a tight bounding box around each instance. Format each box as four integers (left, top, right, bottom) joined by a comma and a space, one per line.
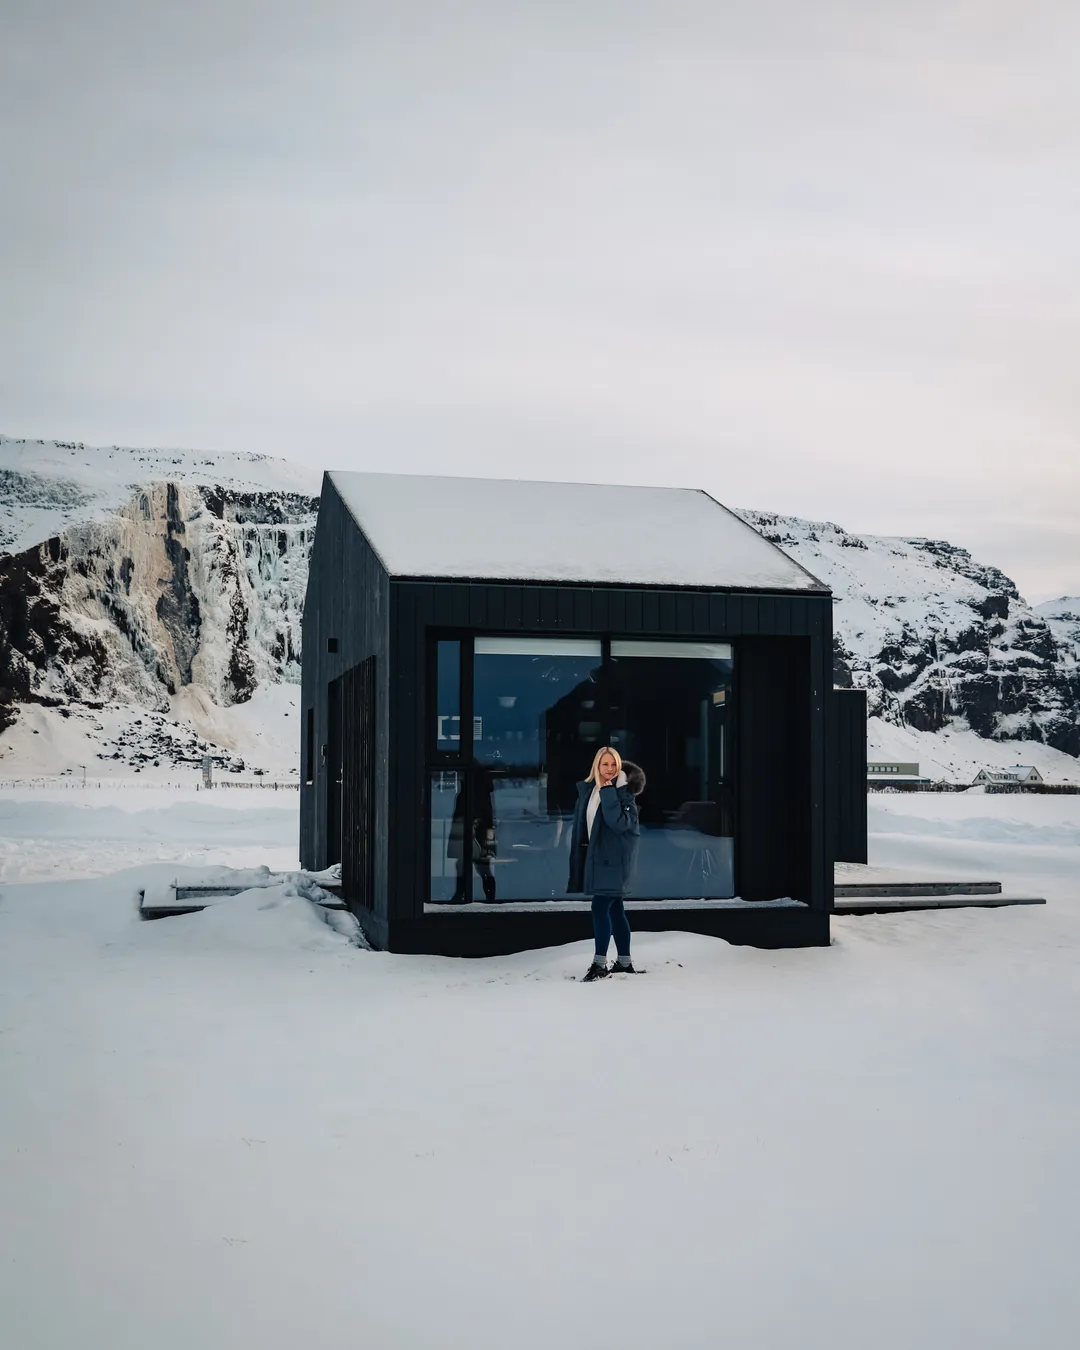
610, 640, 734, 899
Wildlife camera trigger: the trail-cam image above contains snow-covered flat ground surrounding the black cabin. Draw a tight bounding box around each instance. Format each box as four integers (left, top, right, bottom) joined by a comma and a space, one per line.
0, 787, 1080, 1350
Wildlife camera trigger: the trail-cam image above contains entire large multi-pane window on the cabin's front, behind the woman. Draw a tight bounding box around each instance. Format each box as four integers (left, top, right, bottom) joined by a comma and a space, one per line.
431, 637, 734, 903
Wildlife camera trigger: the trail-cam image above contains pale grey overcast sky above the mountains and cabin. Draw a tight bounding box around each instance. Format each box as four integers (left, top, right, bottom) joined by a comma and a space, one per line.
0, 0, 1080, 601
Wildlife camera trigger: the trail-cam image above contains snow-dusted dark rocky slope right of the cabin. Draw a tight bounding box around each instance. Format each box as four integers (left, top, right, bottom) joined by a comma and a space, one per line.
741, 510, 1080, 756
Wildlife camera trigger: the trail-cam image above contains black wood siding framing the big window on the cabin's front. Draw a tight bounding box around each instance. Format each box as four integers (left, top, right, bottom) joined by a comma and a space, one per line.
387, 581, 833, 922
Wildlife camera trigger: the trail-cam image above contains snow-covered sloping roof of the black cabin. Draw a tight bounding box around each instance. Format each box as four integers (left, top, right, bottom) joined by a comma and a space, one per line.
328, 473, 828, 591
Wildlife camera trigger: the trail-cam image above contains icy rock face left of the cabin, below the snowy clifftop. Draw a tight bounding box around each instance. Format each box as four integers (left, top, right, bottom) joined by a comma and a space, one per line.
0, 482, 317, 729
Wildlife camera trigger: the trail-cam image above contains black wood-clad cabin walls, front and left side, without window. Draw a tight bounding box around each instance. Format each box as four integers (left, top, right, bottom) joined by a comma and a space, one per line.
301, 481, 836, 950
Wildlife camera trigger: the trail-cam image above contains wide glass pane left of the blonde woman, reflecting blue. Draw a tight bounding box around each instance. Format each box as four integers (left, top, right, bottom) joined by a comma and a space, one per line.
471, 637, 602, 902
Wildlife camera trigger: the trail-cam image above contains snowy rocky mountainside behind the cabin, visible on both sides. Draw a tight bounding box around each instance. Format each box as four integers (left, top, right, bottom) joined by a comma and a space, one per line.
0, 437, 1080, 778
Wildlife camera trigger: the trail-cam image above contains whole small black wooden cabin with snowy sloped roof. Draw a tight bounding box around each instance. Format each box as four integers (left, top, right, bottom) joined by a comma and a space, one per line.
300, 473, 865, 956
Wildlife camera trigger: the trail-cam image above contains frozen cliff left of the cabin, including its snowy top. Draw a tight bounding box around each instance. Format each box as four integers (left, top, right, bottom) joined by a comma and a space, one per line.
0, 439, 319, 763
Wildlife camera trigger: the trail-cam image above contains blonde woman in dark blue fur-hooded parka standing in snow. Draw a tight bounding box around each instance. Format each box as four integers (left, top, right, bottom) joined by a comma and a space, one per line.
567, 745, 645, 980
